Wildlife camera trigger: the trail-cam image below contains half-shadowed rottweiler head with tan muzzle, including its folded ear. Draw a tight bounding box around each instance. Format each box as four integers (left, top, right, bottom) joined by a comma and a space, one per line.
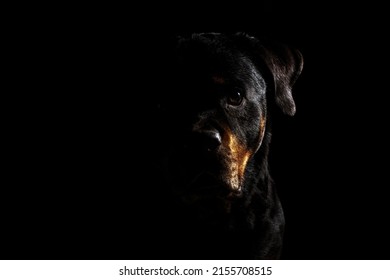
157, 33, 302, 217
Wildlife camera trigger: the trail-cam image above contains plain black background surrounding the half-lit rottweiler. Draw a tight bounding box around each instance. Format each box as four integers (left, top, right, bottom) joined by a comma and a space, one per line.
0, 0, 390, 259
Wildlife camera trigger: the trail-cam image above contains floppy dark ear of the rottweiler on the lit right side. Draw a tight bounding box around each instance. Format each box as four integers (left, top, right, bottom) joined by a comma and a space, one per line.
236, 33, 303, 116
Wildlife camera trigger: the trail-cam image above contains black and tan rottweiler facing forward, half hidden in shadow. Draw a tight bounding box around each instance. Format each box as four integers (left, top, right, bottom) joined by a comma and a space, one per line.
151, 32, 303, 259
